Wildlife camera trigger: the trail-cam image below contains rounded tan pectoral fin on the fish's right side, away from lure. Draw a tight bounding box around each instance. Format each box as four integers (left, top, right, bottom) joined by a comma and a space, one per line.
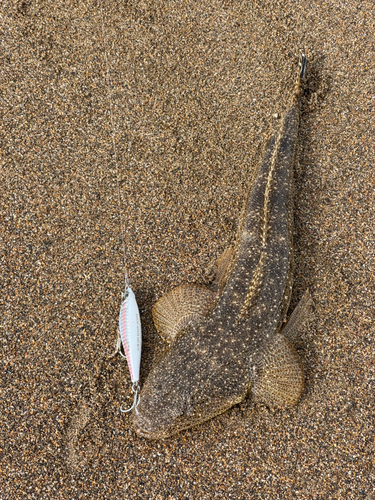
251, 334, 304, 408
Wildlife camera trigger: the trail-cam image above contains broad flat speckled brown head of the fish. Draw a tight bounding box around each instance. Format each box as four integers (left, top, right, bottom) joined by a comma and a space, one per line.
133, 346, 249, 439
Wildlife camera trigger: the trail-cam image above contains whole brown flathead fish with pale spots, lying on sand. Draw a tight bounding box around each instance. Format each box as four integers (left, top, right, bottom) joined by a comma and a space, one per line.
134, 57, 310, 439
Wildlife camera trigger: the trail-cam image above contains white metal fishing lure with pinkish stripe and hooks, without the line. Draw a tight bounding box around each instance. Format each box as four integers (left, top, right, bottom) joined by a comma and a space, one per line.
119, 286, 142, 412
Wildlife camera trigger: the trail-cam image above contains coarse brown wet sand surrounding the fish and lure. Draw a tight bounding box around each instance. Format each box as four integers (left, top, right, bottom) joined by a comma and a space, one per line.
0, 0, 375, 500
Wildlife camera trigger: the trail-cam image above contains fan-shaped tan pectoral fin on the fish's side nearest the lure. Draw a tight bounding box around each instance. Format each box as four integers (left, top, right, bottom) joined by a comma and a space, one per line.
152, 284, 217, 342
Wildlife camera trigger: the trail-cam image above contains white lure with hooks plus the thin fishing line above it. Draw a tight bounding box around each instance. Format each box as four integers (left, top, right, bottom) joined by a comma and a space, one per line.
99, 0, 142, 413
